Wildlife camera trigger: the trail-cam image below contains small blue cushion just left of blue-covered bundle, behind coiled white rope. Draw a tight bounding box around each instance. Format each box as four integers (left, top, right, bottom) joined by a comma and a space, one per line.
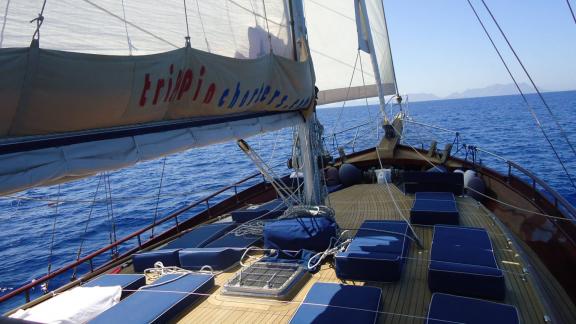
178, 248, 245, 270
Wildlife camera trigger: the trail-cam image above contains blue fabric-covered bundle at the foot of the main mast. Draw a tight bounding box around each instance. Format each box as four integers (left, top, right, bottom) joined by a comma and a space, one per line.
264, 217, 338, 252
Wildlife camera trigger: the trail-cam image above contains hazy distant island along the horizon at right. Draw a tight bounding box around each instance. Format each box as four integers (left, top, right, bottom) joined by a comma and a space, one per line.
408, 83, 548, 101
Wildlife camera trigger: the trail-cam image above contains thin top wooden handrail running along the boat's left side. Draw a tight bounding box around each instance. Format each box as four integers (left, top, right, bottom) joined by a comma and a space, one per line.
0, 173, 260, 303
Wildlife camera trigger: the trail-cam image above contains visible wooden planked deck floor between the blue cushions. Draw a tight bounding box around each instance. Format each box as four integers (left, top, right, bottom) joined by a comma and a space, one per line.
173, 184, 573, 323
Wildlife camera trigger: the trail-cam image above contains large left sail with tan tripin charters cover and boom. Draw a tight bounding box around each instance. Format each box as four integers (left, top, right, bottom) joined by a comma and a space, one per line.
0, 0, 314, 194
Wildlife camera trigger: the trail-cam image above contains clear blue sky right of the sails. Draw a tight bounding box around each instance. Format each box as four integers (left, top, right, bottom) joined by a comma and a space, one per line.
384, 0, 576, 96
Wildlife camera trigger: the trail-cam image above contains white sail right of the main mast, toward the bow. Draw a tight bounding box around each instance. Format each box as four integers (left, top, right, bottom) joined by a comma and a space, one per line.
305, 0, 397, 104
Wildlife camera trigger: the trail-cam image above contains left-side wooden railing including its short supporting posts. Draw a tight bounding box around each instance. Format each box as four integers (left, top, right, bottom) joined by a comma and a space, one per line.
0, 173, 260, 303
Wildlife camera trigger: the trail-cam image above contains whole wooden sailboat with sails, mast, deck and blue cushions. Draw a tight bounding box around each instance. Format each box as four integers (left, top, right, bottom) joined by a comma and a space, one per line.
0, 0, 576, 323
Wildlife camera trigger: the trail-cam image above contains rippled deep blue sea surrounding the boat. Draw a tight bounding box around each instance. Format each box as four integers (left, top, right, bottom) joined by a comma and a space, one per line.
0, 91, 576, 313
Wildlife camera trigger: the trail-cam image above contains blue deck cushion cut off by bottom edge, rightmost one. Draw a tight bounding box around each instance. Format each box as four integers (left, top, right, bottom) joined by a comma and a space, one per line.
426, 293, 520, 324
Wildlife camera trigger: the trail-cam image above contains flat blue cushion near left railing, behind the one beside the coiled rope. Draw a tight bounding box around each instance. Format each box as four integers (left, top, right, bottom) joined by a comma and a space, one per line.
162, 222, 236, 249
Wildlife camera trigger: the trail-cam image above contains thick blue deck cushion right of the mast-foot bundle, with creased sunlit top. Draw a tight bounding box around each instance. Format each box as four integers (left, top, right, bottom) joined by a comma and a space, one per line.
335, 220, 411, 282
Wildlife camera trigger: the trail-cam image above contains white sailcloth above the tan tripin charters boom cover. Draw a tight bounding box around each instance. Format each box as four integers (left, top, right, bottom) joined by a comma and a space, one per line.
0, 0, 293, 58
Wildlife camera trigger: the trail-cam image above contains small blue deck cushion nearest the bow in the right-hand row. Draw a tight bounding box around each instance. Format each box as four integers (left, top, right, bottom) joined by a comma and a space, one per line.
410, 192, 460, 225
